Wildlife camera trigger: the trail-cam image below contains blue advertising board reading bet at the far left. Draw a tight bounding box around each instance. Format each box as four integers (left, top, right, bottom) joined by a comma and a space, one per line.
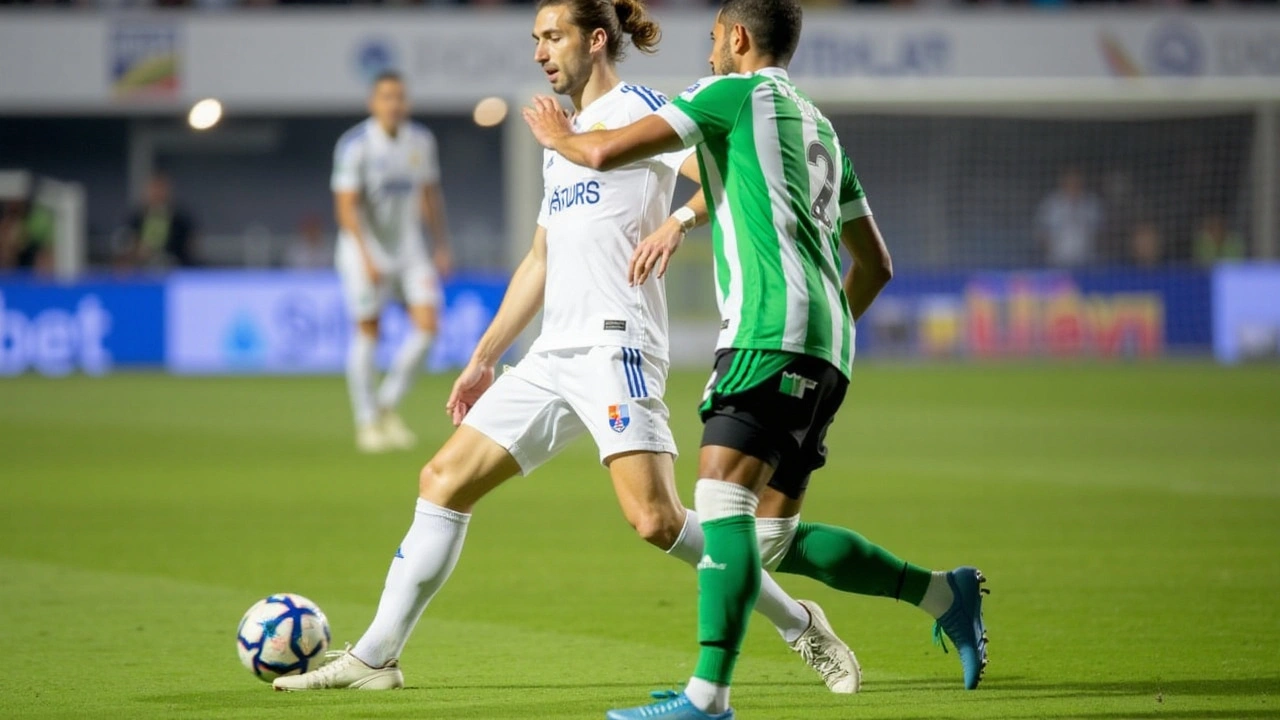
0, 278, 164, 375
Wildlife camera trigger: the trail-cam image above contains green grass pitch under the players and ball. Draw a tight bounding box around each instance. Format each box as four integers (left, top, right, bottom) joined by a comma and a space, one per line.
0, 364, 1280, 720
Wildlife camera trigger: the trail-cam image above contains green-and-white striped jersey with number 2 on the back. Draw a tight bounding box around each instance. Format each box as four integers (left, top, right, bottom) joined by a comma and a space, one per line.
658, 68, 870, 377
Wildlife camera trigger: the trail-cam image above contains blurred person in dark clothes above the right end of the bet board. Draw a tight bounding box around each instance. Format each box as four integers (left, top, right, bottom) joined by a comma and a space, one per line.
122, 174, 197, 268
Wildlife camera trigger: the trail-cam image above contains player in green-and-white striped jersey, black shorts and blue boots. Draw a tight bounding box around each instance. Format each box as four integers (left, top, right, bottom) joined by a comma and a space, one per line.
525, 0, 986, 720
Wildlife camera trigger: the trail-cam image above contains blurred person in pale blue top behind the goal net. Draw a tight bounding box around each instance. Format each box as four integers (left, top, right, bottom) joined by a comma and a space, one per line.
1036, 168, 1102, 268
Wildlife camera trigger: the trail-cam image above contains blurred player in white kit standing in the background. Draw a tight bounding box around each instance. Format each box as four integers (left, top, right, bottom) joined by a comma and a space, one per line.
330, 72, 451, 452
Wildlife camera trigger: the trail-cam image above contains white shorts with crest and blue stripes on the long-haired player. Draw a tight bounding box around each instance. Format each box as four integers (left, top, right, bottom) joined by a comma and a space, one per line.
463, 346, 676, 475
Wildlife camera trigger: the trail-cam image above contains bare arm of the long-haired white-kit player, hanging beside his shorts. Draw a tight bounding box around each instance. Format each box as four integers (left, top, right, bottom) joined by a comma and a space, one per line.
444, 225, 547, 425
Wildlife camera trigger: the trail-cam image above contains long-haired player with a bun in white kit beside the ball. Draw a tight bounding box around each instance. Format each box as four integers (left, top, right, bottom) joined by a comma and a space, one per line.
274, 0, 860, 693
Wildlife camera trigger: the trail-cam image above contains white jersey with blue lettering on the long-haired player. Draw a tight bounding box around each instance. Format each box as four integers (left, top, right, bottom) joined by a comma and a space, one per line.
530, 82, 692, 360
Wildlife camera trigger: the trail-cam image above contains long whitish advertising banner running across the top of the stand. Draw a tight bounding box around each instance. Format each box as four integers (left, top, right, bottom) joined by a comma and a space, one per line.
0, 9, 1280, 113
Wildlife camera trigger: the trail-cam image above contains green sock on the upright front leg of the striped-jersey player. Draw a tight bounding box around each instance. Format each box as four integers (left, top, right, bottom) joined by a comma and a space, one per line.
694, 515, 762, 685
